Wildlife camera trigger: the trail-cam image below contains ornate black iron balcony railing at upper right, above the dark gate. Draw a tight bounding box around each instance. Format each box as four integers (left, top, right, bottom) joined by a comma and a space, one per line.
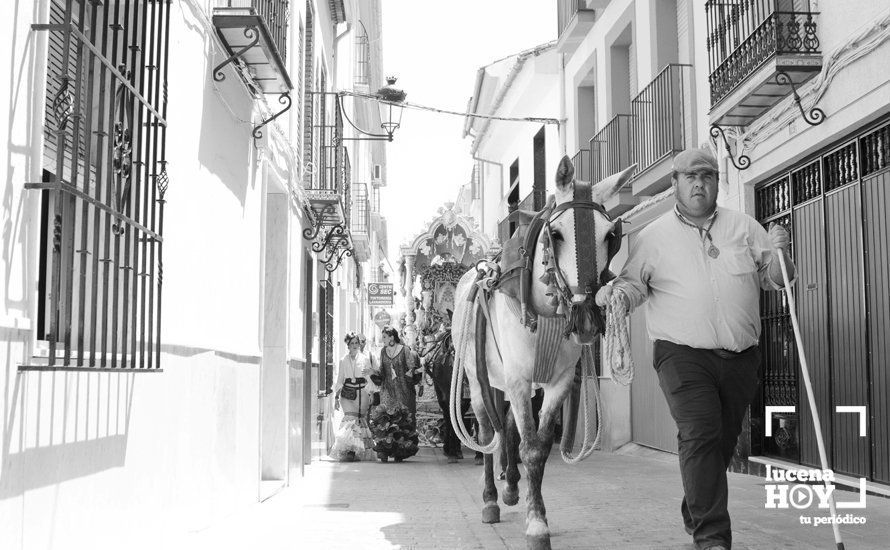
705, 0, 820, 105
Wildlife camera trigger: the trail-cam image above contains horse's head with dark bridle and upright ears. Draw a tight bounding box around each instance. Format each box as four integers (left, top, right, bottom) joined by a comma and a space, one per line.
532, 156, 635, 344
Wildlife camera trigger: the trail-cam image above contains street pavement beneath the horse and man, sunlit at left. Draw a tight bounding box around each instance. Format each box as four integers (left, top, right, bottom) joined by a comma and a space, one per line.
184, 445, 890, 550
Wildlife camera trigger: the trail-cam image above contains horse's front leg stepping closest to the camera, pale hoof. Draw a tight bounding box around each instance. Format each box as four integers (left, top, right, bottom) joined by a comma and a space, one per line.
513, 369, 574, 550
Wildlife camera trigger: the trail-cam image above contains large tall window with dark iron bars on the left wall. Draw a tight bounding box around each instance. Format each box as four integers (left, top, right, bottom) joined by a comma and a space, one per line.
27, 0, 172, 372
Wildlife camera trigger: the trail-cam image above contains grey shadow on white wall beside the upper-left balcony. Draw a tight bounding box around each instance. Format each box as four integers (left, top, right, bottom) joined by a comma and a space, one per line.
177, 2, 254, 207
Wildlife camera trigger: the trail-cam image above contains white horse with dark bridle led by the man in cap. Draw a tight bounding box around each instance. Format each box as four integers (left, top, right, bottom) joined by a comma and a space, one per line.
452, 157, 634, 549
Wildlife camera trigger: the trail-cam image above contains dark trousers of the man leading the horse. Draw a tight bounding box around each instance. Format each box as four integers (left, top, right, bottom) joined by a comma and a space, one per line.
653, 340, 760, 548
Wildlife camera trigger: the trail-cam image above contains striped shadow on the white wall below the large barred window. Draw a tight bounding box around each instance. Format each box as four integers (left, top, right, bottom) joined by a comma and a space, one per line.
0, 350, 137, 500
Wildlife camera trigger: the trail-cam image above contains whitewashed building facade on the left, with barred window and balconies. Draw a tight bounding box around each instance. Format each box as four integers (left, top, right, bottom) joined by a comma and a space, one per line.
0, 0, 386, 548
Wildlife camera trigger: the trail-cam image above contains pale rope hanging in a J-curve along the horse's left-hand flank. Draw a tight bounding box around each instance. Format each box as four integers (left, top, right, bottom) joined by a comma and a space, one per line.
448, 271, 500, 454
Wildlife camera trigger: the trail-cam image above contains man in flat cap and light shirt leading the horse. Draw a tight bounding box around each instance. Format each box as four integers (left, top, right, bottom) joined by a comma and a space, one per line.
597, 149, 794, 550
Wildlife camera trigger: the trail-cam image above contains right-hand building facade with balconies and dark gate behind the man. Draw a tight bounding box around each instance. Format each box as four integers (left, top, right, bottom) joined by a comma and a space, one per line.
557, 0, 890, 490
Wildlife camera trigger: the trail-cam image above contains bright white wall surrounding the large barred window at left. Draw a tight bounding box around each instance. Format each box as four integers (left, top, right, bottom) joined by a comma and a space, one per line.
0, 0, 329, 549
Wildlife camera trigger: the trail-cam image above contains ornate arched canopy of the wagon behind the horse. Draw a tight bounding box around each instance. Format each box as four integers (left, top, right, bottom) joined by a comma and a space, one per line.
400, 203, 500, 344
